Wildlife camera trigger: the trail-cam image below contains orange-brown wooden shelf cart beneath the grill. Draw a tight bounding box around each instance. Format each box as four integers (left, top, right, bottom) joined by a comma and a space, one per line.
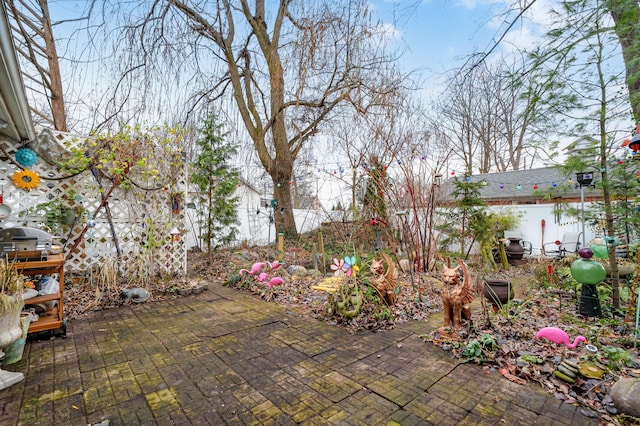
15, 253, 67, 336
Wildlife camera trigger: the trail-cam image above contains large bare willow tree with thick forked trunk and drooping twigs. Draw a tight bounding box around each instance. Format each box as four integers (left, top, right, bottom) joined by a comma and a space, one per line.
94, 0, 402, 238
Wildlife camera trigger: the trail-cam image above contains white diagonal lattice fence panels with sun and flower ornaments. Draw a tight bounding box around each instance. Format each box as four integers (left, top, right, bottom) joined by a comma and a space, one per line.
0, 131, 187, 276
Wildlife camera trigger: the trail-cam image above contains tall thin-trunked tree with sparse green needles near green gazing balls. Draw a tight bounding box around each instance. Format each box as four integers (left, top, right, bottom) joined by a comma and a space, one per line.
532, 0, 637, 308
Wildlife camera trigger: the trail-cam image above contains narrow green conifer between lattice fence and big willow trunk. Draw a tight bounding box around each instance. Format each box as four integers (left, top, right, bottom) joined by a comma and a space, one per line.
191, 116, 240, 252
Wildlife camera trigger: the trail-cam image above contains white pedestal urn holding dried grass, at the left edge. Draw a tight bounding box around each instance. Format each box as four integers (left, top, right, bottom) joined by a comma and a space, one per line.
0, 261, 24, 390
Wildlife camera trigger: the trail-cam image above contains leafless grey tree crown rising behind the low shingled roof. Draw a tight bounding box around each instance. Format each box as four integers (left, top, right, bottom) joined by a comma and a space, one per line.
433, 57, 552, 174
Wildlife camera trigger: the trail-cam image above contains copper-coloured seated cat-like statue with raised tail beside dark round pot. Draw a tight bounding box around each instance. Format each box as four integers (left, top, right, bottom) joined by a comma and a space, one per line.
442, 259, 473, 330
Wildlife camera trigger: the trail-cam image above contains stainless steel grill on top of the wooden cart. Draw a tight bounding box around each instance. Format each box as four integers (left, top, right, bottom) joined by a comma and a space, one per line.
0, 226, 53, 261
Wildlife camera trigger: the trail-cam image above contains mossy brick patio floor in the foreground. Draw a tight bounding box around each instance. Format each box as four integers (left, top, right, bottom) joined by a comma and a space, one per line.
0, 284, 598, 425
